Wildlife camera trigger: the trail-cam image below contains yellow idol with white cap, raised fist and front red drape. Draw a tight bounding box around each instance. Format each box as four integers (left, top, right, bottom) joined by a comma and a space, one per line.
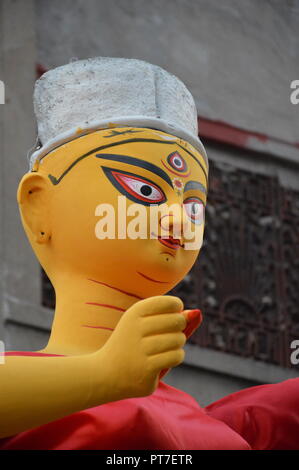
0, 58, 298, 449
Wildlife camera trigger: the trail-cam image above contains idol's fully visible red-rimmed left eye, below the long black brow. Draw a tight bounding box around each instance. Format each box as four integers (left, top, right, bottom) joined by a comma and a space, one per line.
102, 167, 166, 206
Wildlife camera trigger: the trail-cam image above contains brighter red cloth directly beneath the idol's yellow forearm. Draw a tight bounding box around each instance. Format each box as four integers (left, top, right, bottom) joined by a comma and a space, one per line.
0, 382, 249, 450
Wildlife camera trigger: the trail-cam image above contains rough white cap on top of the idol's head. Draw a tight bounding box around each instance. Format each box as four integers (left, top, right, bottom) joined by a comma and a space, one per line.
30, 57, 207, 168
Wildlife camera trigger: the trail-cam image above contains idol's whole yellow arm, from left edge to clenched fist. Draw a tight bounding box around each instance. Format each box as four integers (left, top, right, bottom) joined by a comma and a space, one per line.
0, 296, 188, 438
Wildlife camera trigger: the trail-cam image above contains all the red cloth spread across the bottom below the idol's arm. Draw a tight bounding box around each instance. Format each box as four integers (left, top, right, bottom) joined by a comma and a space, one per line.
0, 353, 299, 450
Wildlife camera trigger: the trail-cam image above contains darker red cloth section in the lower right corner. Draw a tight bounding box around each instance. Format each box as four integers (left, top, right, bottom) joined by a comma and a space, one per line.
206, 377, 299, 450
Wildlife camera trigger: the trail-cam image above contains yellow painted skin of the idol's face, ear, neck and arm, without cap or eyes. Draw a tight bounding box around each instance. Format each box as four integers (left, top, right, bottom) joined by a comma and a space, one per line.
0, 128, 207, 437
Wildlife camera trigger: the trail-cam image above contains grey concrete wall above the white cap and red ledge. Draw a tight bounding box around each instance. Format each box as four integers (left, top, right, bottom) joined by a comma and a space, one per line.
36, 0, 299, 141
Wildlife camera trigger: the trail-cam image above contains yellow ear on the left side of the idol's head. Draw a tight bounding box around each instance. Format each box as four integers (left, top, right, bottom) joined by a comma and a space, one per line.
17, 173, 52, 243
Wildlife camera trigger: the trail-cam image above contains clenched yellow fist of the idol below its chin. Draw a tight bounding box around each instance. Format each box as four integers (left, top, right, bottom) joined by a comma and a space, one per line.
92, 296, 189, 400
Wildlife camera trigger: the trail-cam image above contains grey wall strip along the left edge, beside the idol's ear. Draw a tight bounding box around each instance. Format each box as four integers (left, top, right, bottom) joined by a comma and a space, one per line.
0, 0, 51, 349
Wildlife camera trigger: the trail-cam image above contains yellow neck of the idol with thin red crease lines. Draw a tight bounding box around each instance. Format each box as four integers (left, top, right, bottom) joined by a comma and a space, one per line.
41, 277, 141, 355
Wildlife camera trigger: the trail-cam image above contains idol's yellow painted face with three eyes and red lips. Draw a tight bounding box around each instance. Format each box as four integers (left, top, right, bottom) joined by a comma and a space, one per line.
34, 128, 207, 297
